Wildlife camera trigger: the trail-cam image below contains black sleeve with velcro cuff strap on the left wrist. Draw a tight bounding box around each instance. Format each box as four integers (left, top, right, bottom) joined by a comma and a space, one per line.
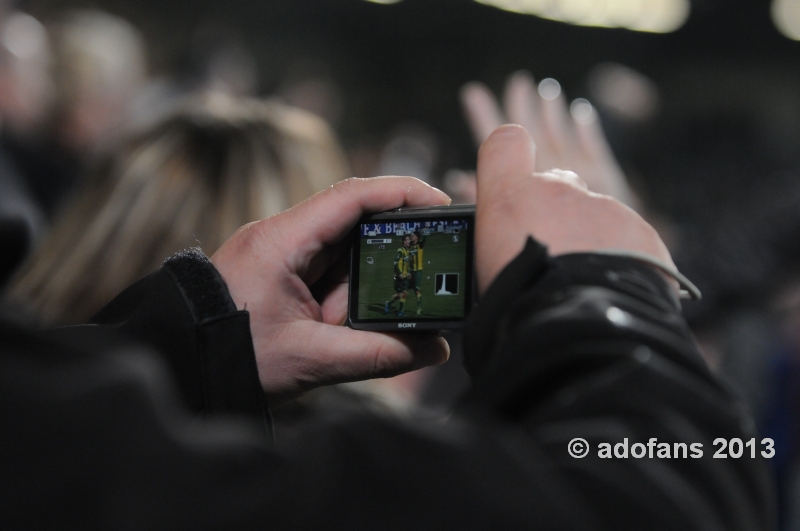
51, 249, 272, 438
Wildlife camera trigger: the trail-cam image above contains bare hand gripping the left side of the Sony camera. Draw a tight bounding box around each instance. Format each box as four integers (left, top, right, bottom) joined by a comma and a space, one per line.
211, 177, 450, 403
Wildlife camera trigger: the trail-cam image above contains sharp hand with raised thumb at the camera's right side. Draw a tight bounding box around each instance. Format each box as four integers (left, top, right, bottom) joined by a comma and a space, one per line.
475, 125, 674, 292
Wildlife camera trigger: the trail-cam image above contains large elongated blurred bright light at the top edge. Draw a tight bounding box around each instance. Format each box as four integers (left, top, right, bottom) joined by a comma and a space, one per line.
475, 0, 690, 33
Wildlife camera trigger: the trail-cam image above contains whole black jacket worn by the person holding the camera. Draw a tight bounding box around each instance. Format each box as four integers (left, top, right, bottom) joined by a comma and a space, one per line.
0, 240, 780, 530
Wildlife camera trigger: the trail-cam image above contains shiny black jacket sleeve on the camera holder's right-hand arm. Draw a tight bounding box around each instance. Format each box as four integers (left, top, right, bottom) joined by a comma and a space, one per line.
463, 239, 775, 530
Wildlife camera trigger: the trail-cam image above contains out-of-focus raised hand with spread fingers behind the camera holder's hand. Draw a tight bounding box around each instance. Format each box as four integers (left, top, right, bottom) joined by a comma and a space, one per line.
461, 72, 641, 211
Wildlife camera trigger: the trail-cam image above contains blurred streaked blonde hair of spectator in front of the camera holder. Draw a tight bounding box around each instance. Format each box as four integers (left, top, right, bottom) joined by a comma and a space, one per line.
10, 95, 347, 324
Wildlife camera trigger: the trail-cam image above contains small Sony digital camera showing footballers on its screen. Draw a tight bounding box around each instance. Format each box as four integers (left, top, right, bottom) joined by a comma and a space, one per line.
350, 209, 474, 329
